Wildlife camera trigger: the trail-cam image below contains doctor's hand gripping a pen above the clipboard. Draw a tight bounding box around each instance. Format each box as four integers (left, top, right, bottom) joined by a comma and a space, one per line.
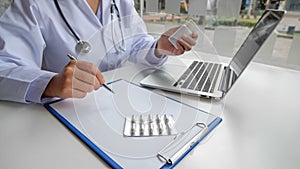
43, 60, 105, 98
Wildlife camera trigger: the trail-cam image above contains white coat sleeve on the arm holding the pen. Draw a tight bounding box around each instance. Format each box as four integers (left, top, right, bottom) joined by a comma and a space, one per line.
0, 0, 55, 103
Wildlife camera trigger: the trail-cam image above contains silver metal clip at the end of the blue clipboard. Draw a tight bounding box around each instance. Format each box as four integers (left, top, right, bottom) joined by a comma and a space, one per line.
157, 123, 208, 165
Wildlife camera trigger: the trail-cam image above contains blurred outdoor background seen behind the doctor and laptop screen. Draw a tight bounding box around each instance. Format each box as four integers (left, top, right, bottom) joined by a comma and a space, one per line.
0, 0, 300, 70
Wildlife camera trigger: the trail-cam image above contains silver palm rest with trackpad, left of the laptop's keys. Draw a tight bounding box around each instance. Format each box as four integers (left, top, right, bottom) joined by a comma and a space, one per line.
141, 64, 187, 88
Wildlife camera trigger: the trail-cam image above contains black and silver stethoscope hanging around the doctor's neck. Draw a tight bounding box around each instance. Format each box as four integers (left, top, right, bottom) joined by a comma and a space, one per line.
54, 0, 126, 53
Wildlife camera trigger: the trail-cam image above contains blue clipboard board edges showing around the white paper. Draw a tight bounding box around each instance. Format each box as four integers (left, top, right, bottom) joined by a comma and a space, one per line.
44, 79, 222, 169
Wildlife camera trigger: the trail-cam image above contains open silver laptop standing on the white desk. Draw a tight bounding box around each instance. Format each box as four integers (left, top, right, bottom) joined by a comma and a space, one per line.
140, 10, 285, 98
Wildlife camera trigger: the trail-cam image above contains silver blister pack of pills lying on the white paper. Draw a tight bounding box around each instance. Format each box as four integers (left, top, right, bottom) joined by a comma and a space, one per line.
124, 114, 177, 137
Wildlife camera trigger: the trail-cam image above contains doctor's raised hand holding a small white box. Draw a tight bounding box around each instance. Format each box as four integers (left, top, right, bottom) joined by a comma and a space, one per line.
155, 27, 198, 57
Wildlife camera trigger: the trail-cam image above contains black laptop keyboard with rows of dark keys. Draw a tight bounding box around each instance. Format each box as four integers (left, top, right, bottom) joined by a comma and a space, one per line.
174, 61, 221, 93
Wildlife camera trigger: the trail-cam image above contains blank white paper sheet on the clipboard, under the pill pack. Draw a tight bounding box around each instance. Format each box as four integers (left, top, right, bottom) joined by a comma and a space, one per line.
51, 80, 216, 169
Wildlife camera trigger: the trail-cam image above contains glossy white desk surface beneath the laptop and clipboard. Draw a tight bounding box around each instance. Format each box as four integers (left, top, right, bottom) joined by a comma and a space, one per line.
0, 54, 300, 169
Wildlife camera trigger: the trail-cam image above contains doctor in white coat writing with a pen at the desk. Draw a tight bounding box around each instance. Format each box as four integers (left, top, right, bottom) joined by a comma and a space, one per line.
0, 0, 197, 103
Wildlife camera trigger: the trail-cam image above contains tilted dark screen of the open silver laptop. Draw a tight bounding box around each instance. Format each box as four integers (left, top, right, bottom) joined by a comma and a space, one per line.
225, 10, 285, 91
